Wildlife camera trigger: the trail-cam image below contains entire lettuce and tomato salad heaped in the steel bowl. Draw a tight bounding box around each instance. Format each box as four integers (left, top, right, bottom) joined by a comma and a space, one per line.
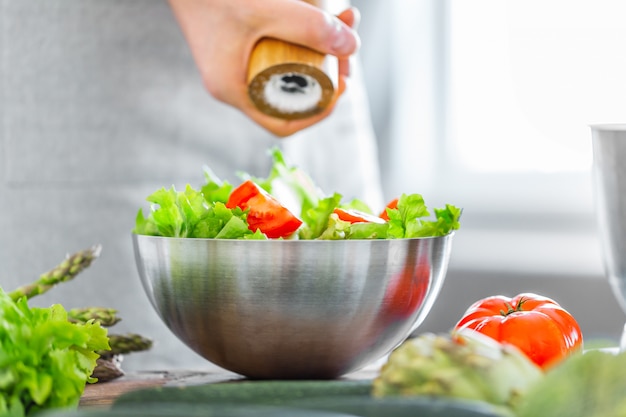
133, 148, 462, 240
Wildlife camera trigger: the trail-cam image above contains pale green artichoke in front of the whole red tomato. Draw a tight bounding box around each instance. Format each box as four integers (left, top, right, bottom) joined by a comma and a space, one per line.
372, 331, 543, 410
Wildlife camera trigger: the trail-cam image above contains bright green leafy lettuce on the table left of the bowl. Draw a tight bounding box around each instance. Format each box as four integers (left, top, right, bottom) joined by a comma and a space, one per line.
0, 289, 109, 417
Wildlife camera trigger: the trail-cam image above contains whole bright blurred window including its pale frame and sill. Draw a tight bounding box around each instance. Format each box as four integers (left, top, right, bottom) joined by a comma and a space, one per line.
387, 0, 626, 273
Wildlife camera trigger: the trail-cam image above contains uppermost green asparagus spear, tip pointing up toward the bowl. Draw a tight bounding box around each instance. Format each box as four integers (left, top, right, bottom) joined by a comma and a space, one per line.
9, 245, 101, 301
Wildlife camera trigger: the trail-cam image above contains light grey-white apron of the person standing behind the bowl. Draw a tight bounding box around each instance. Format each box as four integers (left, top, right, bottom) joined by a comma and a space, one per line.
0, 0, 382, 370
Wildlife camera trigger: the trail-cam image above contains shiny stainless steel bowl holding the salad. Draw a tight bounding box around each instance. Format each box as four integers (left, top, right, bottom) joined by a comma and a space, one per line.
132, 234, 453, 379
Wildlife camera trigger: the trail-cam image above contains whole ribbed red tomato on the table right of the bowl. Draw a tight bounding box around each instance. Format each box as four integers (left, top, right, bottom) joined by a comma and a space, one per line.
455, 293, 583, 369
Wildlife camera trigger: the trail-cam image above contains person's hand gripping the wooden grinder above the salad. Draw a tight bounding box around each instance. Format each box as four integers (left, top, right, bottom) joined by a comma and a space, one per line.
169, 0, 360, 136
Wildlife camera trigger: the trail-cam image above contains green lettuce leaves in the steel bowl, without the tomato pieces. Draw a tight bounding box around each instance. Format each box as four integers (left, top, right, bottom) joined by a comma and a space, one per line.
133, 148, 461, 239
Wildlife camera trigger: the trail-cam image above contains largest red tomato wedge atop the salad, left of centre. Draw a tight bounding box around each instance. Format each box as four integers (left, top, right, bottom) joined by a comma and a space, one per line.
226, 180, 302, 239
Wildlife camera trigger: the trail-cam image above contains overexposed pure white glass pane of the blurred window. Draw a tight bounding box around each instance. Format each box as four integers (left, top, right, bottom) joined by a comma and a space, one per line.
447, 0, 626, 173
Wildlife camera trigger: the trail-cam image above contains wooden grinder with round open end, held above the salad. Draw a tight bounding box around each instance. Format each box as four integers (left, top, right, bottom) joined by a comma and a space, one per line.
248, 0, 339, 120
